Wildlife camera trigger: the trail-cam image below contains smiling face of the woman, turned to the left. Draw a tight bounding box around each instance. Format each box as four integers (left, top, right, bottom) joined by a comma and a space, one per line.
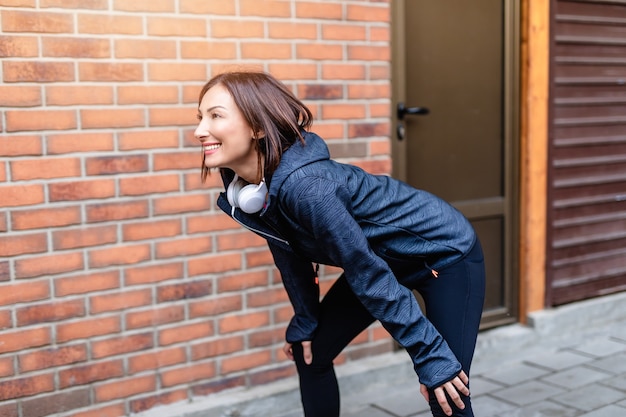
195, 84, 258, 181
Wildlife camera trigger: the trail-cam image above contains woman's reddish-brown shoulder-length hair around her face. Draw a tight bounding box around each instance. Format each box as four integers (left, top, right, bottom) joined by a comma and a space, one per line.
198, 71, 313, 182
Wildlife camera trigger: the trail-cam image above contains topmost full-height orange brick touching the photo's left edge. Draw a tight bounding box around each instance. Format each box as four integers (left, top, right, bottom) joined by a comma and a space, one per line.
2, 10, 74, 33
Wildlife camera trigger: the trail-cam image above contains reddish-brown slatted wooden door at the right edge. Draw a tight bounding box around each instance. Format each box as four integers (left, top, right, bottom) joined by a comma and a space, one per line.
547, 0, 626, 305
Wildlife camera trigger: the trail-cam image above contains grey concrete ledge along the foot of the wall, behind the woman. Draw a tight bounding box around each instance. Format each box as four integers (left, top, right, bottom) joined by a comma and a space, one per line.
134, 292, 626, 417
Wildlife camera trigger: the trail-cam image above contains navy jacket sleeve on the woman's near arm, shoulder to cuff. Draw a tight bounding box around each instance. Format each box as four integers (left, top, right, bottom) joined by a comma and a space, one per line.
283, 176, 461, 388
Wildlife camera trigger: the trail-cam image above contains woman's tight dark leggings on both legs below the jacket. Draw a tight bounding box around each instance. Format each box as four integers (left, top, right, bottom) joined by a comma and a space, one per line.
293, 242, 485, 417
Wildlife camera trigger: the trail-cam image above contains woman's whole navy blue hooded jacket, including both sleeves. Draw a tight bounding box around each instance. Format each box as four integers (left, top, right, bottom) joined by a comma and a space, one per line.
218, 132, 476, 388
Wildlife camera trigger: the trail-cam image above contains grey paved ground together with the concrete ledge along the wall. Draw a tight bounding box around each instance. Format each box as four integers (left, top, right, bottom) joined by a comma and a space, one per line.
141, 292, 626, 417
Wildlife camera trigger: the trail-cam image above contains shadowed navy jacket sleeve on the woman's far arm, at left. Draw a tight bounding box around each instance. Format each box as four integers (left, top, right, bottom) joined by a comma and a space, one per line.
268, 241, 320, 343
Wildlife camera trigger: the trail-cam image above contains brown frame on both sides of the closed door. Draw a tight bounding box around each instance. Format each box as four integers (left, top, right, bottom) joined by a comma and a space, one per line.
391, 0, 524, 328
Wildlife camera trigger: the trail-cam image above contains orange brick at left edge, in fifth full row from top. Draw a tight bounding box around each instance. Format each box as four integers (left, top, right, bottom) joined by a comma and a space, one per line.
6, 110, 77, 131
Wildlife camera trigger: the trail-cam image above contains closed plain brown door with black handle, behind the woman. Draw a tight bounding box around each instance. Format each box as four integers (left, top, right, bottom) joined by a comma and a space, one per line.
394, 0, 517, 326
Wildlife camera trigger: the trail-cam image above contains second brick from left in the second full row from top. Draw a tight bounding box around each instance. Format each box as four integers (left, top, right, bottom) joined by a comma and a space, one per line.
41, 36, 111, 58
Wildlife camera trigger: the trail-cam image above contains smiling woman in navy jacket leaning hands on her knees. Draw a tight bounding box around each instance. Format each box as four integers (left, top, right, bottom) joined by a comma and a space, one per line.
195, 72, 484, 417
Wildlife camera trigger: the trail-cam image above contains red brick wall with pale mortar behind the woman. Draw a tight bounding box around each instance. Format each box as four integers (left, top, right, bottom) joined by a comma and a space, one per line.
0, 0, 391, 417
